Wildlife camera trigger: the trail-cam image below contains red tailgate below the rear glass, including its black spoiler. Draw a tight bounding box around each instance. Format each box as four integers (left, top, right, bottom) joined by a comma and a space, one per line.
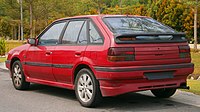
111, 33, 191, 66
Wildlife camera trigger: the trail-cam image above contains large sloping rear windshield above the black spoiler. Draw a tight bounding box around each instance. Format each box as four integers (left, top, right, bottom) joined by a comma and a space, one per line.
103, 17, 176, 33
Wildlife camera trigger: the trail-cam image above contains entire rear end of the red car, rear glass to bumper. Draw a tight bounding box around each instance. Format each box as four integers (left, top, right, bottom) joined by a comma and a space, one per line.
95, 16, 194, 96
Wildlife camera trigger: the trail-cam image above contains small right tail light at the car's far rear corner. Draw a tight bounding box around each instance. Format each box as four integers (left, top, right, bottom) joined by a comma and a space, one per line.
179, 46, 190, 58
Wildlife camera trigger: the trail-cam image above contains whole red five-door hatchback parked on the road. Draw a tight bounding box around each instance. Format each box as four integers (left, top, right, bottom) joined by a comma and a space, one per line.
6, 15, 194, 107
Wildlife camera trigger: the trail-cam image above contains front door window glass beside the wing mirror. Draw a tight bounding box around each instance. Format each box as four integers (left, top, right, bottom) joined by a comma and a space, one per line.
39, 22, 65, 45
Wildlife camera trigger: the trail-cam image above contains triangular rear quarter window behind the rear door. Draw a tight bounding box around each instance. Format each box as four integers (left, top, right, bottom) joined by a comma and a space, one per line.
89, 21, 103, 44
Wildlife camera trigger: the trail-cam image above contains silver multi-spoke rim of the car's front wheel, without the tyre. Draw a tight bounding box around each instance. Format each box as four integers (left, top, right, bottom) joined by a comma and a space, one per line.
13, 64, 22, 87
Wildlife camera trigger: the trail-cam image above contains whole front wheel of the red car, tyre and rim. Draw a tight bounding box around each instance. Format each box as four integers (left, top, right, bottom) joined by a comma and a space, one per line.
11, 61, 30, 90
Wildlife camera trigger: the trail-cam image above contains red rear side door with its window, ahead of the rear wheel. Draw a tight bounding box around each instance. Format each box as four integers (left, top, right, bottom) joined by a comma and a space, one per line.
53, 19, 88, 83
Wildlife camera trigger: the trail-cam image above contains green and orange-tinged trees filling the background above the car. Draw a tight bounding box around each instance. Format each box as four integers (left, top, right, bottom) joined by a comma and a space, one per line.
0, 0, 200, 40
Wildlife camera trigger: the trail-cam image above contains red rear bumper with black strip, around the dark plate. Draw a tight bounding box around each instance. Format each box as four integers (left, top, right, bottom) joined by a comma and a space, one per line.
94, 63, 194, 96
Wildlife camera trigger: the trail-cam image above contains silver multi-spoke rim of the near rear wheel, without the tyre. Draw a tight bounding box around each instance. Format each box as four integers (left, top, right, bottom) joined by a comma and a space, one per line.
77, 74, 93, 102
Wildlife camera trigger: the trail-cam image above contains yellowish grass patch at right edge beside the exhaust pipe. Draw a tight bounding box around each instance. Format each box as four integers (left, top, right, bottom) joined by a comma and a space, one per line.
183, 79, 200, 95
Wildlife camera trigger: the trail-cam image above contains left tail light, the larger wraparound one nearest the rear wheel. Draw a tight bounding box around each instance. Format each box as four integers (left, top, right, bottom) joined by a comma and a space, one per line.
108, 47, 135, 61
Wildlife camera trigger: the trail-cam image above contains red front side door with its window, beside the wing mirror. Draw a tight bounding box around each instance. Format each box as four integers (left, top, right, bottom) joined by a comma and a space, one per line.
25, 21, 66, 81
